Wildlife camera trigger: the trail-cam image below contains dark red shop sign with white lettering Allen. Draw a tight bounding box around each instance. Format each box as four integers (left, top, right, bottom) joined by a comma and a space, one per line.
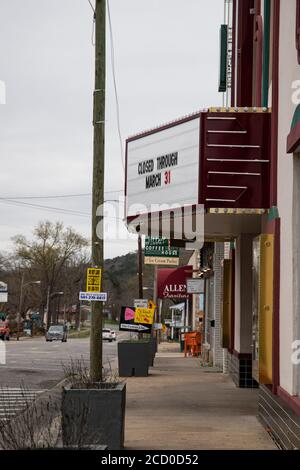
157, 266, 193, 299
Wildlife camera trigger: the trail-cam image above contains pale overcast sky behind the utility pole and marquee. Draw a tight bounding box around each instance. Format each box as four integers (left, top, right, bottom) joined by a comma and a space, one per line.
0, 0, 224, 257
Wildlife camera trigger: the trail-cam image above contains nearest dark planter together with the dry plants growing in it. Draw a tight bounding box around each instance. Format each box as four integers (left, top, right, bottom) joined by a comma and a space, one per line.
62, 359, 126, 450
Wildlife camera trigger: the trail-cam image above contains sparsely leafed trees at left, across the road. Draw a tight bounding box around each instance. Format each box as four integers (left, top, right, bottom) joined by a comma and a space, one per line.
0, 221, 89, 328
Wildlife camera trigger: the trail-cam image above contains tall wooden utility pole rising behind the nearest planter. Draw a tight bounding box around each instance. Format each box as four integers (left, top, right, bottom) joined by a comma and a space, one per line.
90, 0, 106, 382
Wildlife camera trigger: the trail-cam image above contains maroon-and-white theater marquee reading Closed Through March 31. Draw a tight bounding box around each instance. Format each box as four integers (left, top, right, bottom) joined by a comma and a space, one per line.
125, 108, 271, 239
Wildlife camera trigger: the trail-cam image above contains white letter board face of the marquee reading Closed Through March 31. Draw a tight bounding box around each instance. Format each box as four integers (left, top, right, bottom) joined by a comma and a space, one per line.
126, 115, 200, 217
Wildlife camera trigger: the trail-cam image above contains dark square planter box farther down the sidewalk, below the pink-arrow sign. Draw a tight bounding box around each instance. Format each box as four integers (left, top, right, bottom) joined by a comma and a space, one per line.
118, 341, 153, 377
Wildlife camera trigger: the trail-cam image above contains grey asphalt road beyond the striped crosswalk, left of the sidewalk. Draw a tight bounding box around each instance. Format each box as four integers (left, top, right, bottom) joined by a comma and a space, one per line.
0, 333, 124, 390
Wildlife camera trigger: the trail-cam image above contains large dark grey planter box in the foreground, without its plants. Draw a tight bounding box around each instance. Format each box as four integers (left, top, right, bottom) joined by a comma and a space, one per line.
62, 383, 126, 450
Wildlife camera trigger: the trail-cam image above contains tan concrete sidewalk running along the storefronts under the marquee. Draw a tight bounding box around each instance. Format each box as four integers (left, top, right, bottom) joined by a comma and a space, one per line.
125, 343, 277, 450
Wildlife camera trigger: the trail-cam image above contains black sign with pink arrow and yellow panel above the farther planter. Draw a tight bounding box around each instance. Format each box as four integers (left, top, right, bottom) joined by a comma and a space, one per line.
119, 307, 154, 333
